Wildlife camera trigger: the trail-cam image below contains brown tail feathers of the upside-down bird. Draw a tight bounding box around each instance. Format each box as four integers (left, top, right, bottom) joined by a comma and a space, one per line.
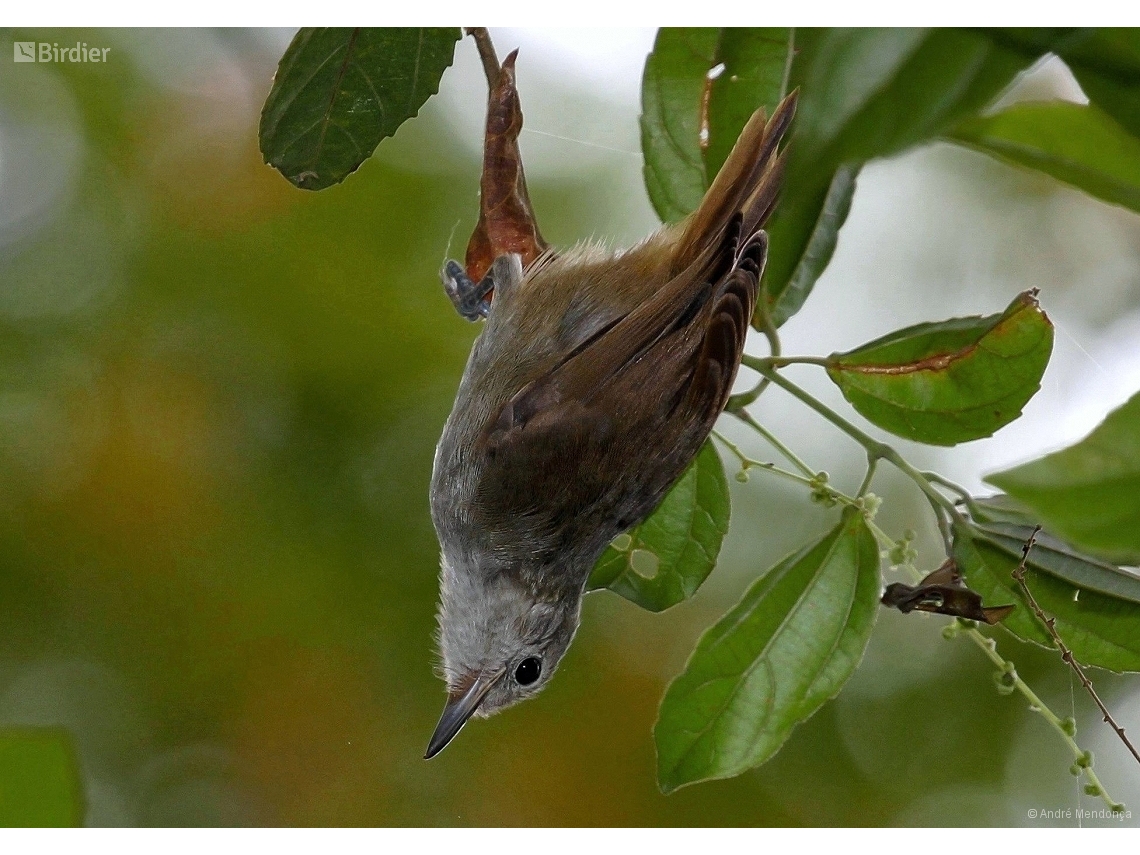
673, 92, 797, 272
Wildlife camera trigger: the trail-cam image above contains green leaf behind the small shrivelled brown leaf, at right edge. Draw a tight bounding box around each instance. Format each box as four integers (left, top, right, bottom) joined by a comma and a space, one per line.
953, 527, 1140, 673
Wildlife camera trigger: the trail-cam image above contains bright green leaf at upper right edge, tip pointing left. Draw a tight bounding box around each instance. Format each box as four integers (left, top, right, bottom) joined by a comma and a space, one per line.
947, 101, 1140, 211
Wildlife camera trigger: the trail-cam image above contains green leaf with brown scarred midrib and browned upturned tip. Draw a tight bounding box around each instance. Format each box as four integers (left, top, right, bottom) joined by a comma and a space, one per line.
828, 293, 1053, 446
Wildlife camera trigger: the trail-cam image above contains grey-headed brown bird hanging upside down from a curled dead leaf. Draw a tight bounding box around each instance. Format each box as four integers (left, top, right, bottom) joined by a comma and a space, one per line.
424, 92, 796, 758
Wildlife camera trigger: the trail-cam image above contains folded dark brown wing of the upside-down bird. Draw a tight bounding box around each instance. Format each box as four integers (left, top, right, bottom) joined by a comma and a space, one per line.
479, 229, 767, 539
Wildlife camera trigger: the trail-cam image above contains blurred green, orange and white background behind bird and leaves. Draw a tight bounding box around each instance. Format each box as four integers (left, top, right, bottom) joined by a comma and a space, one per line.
0, 30, 1140, 825
